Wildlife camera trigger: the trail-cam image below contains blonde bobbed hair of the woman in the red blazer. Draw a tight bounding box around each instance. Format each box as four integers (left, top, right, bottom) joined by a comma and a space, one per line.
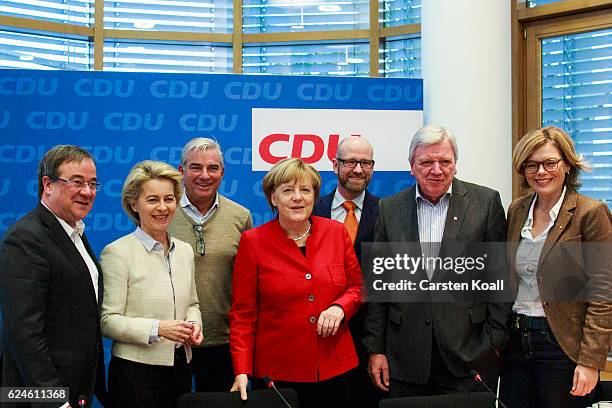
263, 158, 322, 211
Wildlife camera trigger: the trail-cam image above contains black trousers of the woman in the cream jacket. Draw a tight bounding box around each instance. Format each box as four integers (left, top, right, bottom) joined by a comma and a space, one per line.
108, 347, 191, 408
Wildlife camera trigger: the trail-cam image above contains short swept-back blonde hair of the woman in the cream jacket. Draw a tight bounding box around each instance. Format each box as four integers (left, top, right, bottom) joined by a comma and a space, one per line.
121, 160, 183, 226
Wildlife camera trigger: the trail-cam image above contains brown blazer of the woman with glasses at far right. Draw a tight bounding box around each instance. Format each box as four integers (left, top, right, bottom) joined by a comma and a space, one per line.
508, 190, 612, 370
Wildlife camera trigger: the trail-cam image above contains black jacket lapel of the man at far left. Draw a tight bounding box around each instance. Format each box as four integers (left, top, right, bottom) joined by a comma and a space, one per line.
36, 204, 102, 312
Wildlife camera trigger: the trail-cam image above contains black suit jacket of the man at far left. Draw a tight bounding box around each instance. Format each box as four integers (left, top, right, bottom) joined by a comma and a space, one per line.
0, 204, 105, 407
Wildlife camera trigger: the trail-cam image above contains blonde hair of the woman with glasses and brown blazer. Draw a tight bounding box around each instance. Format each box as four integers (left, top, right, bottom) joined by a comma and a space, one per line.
512, 126, 590, 190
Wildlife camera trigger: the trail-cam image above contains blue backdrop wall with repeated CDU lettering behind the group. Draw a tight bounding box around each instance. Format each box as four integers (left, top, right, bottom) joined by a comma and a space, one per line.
0, 70, 423, 404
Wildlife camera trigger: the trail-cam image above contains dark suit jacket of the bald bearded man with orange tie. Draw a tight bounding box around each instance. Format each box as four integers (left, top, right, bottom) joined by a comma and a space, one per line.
312, 190, 380, 262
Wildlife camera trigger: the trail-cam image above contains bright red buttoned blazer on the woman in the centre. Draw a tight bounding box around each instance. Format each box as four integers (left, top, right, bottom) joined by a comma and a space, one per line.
229, 216, 362, 382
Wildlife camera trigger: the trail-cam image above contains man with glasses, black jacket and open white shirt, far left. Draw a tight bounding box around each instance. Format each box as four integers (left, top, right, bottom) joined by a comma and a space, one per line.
0, 145, 106, 407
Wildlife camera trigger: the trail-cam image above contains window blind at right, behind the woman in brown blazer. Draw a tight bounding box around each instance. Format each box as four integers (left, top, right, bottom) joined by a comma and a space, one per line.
542, 29, 612, 206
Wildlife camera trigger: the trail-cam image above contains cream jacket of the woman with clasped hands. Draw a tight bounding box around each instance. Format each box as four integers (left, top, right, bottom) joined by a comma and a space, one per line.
100, 234, 202, 366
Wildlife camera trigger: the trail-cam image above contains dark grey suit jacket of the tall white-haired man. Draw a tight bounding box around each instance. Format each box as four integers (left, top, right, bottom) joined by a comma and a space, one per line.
363, 179, 511, 384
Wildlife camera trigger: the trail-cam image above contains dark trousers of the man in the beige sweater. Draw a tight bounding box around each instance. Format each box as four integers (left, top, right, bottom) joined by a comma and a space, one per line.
191, 344, 234, 392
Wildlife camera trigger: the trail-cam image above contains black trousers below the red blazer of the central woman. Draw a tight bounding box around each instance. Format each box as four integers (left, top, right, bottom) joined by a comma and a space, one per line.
251, 373, 352, 408
